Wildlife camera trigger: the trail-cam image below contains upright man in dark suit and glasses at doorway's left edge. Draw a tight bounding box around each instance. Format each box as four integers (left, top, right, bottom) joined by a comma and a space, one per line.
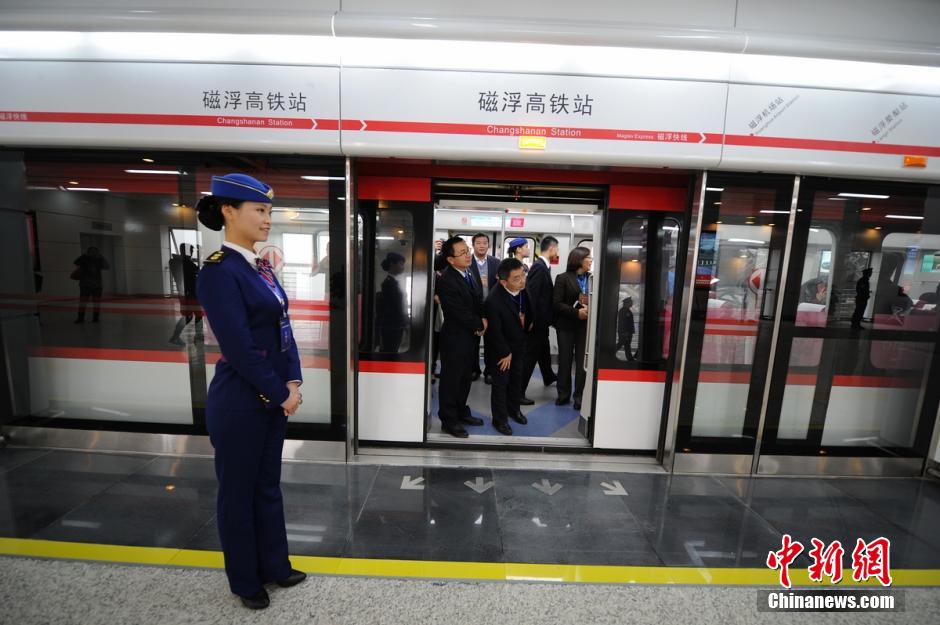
435, 237, 487, 438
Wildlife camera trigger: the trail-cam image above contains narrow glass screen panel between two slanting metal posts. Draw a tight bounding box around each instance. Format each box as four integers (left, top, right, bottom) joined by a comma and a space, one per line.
676, 175, 794, 454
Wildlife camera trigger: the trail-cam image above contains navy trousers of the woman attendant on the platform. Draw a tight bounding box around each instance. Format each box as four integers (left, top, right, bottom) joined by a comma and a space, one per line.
206, 405, 291, 597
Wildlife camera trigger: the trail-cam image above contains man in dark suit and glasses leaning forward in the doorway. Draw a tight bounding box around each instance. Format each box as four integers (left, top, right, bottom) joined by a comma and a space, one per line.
485, 258, 532, 436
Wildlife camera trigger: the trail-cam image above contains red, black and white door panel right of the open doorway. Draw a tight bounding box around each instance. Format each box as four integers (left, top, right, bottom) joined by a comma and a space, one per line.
593, 202, 687, 452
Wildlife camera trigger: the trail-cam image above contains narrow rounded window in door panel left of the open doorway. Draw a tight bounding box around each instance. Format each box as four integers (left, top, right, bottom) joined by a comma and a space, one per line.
372, 209, 414, 353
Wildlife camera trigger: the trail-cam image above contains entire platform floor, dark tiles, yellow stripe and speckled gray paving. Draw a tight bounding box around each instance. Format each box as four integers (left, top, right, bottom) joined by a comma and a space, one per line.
0, 448, 940, 623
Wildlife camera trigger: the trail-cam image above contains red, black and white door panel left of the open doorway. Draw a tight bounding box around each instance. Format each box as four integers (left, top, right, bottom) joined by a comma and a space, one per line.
357, 177, 433, 443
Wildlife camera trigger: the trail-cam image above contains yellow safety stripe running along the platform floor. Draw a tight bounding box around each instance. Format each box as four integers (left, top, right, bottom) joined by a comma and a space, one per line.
0, 538, 940, 587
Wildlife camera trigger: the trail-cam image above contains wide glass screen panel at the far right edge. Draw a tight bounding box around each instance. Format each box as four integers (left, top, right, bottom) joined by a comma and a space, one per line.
761, 179, 940, 472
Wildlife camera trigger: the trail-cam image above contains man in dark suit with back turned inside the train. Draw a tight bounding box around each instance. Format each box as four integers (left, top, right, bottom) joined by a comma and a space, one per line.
519, 237, 558, 406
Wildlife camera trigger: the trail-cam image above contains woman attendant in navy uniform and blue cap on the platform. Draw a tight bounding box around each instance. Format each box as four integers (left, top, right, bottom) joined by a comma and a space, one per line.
196, 174, 306, 610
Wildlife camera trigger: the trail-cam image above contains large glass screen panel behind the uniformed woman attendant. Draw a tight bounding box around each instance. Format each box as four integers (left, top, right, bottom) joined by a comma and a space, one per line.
5, 150, 341, 437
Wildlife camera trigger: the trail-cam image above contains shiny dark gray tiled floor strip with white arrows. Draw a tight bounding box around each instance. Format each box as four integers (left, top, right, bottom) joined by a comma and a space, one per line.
0, 449, 940, 568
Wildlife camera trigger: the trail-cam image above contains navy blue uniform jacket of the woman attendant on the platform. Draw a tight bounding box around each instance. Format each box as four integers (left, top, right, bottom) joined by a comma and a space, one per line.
196, 248, 302, 410
